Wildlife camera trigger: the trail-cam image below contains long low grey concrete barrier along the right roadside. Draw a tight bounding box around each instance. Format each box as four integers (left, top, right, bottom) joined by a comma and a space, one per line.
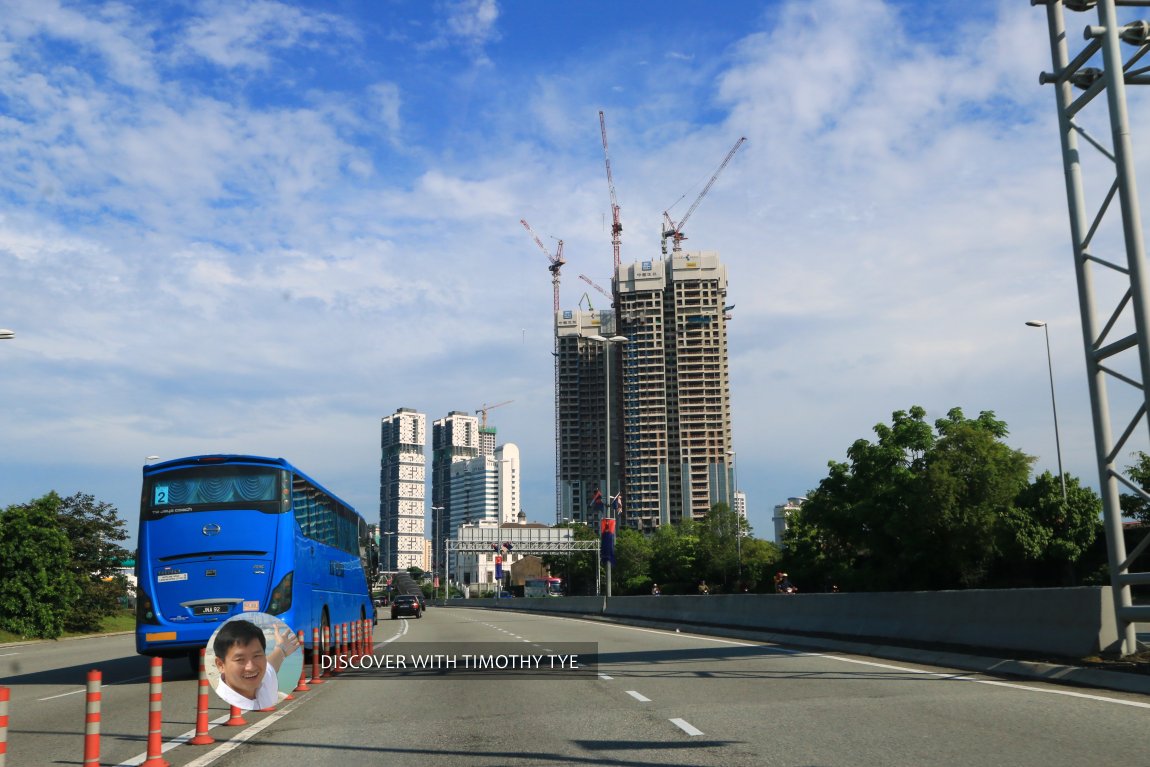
447, 586, 1119, 658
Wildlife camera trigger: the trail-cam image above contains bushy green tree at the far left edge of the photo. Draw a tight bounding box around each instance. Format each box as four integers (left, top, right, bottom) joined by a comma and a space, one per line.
0, 493, 79, 639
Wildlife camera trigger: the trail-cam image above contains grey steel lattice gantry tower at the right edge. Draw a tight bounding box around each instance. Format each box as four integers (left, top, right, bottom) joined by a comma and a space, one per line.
1032, 0, 1150, 654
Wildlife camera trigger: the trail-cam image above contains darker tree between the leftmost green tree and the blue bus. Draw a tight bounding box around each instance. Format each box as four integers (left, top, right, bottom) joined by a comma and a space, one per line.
54, 492, 129, 631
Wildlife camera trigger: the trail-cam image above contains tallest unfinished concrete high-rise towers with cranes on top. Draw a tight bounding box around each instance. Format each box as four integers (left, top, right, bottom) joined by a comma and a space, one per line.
555, 251, 734, 530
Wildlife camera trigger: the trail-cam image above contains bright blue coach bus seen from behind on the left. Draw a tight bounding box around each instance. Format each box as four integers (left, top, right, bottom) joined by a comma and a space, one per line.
136, 455, 375, 665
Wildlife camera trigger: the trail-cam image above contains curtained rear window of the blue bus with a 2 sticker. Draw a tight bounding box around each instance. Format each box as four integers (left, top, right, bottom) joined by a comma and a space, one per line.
141, 465, 285, 519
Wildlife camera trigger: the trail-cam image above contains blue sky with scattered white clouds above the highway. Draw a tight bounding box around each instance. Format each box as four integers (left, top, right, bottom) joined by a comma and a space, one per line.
0, 0, 1150, 549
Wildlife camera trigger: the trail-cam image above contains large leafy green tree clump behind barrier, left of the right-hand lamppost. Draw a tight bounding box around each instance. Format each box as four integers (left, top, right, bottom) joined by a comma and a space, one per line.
784, 406, 1033, 590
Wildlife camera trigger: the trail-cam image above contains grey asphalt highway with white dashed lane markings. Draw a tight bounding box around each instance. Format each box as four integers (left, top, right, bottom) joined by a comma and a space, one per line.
0, 607, 1150, 767
